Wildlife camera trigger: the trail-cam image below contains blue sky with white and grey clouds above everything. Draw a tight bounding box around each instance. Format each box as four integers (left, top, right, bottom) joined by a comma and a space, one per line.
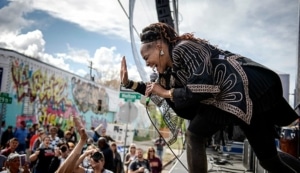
0, 0, 298, 104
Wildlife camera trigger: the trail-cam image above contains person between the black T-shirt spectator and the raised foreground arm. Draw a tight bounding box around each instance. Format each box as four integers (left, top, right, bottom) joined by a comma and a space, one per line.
48, 143, 70, 173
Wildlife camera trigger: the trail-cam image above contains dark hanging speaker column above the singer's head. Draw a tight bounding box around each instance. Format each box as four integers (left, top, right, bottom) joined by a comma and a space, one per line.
155, 0, 174, 28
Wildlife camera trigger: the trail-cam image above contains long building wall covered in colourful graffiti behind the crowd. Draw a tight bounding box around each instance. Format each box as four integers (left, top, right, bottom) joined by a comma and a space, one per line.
0, 49, 120, 129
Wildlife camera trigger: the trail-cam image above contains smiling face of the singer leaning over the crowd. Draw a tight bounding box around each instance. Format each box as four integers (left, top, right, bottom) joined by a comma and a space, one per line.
141, 41, 170, 73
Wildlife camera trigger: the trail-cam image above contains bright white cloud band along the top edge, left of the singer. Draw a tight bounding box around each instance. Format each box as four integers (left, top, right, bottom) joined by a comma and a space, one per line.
32, 0, 129, 39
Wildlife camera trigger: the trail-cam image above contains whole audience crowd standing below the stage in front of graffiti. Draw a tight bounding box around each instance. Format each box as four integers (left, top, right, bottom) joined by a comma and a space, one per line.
0, 117, 162, 173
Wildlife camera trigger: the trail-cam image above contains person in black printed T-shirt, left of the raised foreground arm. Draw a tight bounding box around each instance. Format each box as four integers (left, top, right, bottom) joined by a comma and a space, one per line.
29, 136, 55, 173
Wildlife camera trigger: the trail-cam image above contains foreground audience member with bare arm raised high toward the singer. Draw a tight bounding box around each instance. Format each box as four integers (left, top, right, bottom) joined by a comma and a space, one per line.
55, 117, 112, 173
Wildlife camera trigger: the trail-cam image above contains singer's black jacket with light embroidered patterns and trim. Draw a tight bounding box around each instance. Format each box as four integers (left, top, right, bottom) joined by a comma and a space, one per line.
165, 40, 266, 124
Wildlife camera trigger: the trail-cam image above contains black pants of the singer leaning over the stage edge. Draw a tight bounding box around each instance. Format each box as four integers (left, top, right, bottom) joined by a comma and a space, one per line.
187, 98, 300, 173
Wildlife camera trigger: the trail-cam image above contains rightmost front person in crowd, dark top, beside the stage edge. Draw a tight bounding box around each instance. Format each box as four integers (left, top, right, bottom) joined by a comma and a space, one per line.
147, 147, 162, 173
